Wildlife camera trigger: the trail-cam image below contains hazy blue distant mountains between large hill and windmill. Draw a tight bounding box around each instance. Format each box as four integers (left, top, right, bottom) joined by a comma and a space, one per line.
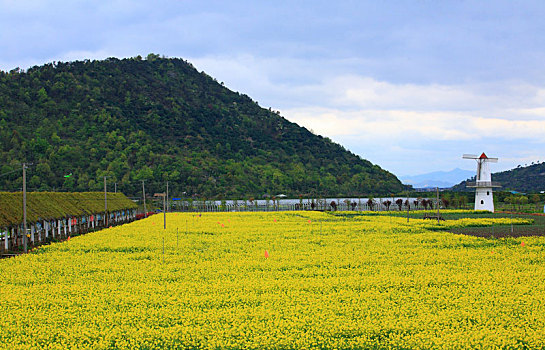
399, 168, 475, 188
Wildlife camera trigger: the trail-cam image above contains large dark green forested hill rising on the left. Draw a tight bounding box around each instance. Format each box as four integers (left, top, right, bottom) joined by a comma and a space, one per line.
0, 54, 403, 198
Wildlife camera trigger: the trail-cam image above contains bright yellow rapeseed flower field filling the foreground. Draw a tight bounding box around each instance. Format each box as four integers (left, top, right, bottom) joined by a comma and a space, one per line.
0, 212, 545, 349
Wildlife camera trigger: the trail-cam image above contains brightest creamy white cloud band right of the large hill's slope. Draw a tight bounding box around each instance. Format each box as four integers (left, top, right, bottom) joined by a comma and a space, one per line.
283, 108, 545, 142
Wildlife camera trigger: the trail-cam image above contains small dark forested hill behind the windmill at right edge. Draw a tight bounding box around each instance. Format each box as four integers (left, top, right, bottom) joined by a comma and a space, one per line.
453, 162, 545, 192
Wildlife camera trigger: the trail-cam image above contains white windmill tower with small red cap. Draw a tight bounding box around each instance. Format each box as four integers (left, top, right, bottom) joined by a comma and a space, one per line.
462, 152, 501, 212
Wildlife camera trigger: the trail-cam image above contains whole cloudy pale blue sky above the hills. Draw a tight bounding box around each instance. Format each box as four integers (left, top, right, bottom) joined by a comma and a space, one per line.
0, 0, 545, 176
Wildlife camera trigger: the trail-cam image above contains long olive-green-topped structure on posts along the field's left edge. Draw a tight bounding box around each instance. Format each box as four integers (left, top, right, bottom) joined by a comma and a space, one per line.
0, 192, 137, 254
